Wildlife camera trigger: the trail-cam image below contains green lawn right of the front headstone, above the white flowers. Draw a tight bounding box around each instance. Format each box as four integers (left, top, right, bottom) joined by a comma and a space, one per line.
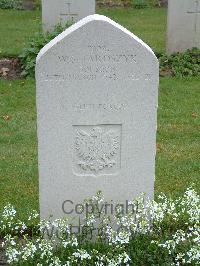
156, 77, 200, 196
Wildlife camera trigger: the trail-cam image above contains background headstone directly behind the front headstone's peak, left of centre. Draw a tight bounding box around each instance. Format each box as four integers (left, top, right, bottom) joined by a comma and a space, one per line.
42, 0, 95, 32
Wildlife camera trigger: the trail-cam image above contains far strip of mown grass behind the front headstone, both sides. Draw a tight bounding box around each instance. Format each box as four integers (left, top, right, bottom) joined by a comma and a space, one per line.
0, 8, 166, 57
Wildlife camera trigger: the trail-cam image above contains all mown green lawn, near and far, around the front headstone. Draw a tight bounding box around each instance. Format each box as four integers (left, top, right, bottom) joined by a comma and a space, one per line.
0, 9, 200, 217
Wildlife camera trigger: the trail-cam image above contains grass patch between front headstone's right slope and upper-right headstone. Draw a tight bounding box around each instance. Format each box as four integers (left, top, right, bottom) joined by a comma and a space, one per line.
99, 8, 167, 52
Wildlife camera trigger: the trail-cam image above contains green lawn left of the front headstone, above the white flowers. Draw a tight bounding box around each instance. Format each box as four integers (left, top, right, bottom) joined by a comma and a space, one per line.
0, 80, 38, 218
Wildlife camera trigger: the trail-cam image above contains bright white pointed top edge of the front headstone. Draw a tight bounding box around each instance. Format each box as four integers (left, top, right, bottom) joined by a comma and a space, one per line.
36, 14, 157, 63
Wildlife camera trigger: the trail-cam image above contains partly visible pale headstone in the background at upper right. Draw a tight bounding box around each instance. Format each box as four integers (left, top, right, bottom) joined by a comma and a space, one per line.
167, 0, 200, 54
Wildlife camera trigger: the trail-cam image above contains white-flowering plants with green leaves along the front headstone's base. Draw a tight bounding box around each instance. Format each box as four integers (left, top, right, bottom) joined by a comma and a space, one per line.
0, 188, 200, 266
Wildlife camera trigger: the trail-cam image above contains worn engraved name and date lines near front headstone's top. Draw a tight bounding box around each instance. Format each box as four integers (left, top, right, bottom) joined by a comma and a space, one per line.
41, 43, 155, 81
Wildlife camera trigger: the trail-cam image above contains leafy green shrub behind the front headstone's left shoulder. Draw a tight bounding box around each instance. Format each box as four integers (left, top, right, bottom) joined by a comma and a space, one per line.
19, 25, 69, 77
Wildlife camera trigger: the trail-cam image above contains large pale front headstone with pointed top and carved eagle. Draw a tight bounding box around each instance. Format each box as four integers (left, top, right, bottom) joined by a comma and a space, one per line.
36, 15, 159, 218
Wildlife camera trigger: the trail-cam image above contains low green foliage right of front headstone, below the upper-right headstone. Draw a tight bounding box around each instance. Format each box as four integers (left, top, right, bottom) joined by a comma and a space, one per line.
158, 48, 200, 78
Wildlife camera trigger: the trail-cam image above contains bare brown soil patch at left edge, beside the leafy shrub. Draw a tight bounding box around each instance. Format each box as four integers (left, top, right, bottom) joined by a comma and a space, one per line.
0, 58, 22, 80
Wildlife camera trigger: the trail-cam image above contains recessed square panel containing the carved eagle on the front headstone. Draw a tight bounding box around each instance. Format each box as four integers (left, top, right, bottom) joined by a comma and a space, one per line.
74, 125, 121, 175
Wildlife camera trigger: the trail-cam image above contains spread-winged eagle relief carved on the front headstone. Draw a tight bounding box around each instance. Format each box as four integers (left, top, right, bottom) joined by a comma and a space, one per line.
75, 127, 119, 173
